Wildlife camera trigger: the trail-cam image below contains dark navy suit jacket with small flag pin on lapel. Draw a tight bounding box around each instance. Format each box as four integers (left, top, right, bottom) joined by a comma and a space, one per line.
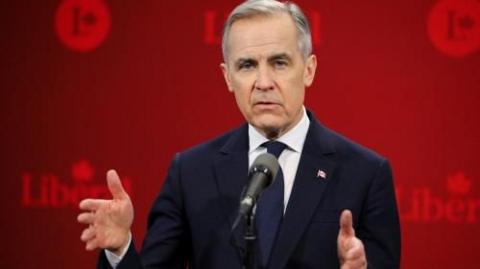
98, 113, 400, 269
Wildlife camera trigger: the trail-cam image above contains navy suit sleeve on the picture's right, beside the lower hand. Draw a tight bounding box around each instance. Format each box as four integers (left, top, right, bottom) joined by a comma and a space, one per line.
357, 160, 401, 269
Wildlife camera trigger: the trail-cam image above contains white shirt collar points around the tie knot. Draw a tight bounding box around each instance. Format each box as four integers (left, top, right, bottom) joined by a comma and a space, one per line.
248, 107, 310, 153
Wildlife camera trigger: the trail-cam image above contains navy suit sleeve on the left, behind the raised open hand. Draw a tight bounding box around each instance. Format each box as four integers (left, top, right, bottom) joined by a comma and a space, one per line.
97, 154, 191, 269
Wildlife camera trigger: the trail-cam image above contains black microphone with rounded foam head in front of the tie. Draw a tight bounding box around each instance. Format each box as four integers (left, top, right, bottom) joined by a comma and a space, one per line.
239, 153, 280, 216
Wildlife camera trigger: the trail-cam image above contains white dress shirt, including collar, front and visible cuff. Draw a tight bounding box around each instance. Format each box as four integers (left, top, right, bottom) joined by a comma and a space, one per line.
105, 107, 310, 269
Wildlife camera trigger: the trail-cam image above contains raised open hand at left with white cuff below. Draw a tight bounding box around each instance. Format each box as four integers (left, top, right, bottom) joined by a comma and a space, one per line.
77, 170, 133, 256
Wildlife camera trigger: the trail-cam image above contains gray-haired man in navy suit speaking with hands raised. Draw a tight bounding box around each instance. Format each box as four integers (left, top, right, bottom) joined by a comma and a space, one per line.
78, 0, 400, 269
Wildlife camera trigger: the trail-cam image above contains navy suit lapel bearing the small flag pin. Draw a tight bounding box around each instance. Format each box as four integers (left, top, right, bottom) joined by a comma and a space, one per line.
269, 115, 335, 268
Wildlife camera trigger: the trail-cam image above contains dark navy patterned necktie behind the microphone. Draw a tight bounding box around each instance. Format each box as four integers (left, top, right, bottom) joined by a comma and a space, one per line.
256, 141, 287, 267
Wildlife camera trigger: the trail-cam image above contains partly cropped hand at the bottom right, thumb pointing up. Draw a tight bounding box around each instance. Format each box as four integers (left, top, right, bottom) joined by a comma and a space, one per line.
337, 210, 367, 269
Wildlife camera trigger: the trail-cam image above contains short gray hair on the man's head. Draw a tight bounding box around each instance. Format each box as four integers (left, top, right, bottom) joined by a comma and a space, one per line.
222, 0, 312, 62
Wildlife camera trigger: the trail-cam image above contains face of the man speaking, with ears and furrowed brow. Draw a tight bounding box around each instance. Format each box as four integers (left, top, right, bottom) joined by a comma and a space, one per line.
221, 13, 316, 139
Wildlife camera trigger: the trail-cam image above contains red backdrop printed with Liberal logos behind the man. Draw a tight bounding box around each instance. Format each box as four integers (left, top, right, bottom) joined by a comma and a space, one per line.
0, 0, 480, 269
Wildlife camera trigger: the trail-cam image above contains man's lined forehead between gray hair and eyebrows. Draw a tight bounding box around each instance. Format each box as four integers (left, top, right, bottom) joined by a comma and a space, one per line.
228, 13, 298, 60
